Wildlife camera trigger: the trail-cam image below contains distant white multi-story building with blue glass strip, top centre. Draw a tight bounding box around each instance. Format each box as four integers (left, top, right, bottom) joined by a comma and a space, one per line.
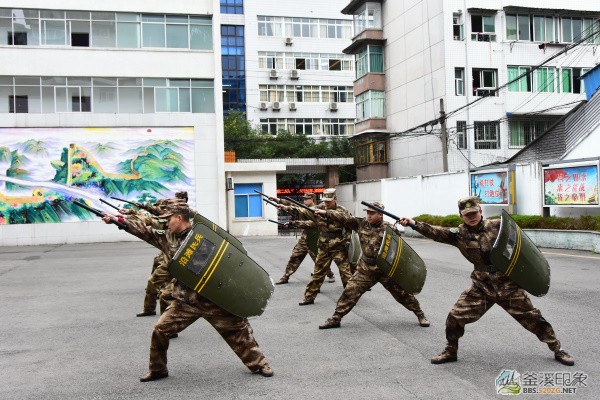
221, 0, 355, 138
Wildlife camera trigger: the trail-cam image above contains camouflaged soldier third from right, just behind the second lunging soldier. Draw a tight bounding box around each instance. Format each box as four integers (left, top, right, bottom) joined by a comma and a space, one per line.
279, 189, 352, 306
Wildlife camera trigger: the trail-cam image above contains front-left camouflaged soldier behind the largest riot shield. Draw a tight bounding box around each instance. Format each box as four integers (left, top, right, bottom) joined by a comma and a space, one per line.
102, 204, 273, 382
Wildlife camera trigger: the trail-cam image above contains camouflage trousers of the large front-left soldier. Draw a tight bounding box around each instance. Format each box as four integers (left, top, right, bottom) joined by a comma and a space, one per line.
150, 298, 268, 372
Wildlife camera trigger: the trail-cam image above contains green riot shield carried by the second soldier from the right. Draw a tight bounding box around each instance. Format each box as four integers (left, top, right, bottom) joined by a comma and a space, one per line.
377, 226, 427, 294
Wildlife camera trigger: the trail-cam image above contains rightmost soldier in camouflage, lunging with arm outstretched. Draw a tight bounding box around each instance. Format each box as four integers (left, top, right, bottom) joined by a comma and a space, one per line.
399, 197, 575, 365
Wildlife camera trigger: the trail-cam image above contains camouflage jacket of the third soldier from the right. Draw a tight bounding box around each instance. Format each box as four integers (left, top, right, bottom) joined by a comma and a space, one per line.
291, 203, 352, 251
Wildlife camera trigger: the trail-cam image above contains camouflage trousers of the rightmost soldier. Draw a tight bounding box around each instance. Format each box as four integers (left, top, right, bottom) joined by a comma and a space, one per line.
446, 278, 560, 353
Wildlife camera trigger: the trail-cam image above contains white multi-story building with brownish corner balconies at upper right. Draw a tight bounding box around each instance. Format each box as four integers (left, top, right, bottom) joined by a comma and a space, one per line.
342, 0, 600, 180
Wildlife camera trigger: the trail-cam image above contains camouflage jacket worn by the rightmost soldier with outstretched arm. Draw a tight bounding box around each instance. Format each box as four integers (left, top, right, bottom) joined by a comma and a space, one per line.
414, 219, 518, 296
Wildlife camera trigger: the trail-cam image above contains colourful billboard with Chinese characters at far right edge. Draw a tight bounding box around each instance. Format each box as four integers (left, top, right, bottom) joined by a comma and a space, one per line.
544, 164, 598, 206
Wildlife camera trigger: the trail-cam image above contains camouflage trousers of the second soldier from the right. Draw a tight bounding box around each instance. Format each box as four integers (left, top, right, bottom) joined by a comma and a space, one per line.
332, 260, 424, 321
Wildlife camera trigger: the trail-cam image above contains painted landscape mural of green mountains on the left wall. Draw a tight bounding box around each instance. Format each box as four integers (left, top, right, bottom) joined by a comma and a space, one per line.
0, 127, 195, 224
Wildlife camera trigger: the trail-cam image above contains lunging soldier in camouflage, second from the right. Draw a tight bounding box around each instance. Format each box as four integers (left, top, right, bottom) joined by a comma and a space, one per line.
316, 202, 429, 329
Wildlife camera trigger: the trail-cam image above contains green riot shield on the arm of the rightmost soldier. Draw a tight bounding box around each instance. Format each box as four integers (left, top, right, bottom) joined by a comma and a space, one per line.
490, 210, 550, 296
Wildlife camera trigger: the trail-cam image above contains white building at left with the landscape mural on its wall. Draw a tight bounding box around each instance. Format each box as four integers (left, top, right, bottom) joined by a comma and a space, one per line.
0, 0, 227, 245
